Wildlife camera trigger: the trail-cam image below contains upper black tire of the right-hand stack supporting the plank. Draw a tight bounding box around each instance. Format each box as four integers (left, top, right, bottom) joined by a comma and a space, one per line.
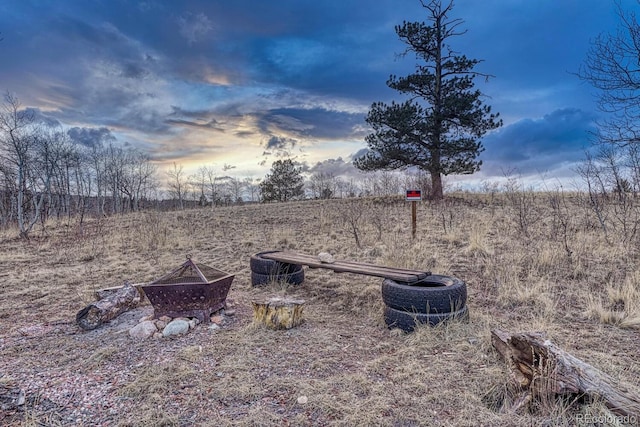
382, 274, 467, 314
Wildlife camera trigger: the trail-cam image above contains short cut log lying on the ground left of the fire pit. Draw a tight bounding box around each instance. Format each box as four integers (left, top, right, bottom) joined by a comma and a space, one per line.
76, 282, 140, 331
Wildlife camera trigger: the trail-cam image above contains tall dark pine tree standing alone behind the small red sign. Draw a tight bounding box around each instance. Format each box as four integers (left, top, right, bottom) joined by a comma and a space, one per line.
354, 0, 502, 199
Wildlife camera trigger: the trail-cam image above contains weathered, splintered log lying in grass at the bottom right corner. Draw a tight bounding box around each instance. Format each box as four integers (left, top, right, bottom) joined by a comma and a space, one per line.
491, 329, 640, 420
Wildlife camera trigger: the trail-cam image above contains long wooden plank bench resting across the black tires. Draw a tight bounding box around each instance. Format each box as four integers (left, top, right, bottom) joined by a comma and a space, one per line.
260, 252, 431, 282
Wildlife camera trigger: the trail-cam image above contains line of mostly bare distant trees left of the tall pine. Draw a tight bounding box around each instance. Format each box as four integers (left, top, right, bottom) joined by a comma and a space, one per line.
0, 93, 438, 238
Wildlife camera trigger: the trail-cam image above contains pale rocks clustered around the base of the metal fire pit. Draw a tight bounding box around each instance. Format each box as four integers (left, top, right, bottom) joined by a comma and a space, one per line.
129, 310, 234, 339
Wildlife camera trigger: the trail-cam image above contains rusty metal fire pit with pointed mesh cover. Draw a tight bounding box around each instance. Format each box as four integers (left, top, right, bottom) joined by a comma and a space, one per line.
141, 257, 235, 323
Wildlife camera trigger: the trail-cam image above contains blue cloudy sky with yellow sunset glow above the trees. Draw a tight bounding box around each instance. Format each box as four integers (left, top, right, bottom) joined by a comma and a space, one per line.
0, 0, 639, 187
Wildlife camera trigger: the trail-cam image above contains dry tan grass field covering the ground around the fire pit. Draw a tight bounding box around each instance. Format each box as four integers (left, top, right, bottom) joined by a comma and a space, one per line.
0, 193, 640, 426
